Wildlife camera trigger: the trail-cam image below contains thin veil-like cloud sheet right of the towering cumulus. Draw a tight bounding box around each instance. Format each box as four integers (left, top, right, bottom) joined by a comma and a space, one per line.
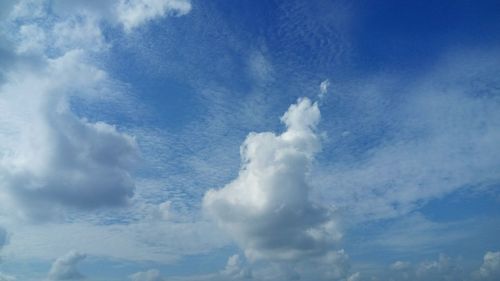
313, 51, 500, 221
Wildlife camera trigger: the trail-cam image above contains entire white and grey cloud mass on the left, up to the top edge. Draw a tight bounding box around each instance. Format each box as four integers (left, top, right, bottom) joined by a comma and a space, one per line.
0, 0, 191, 219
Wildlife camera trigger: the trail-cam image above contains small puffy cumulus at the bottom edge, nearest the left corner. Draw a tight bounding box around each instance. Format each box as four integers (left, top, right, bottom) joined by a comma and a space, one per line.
49, 252, 86, 281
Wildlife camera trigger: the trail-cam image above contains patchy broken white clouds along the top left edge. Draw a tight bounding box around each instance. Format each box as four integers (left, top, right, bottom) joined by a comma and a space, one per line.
10, 0, 192, 45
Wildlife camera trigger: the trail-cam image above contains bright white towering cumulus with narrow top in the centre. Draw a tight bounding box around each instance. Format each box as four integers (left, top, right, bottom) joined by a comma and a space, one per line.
203, 98, 343, 266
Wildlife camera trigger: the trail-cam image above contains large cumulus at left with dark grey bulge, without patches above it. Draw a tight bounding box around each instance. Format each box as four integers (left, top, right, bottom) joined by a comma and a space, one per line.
0, 52, 138, 220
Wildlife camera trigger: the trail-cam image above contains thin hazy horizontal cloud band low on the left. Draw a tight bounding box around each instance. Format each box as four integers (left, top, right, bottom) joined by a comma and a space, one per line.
2, 218, 229, 264
